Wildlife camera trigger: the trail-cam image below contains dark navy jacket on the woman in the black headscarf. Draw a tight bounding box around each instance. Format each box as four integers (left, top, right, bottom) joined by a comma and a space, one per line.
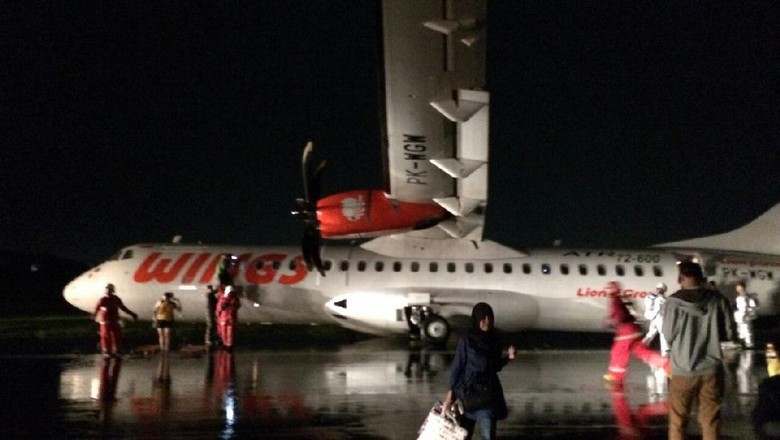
449, 328, 509, 420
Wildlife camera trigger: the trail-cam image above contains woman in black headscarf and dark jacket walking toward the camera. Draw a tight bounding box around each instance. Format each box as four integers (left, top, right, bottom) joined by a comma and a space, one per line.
443, 302, 517, 440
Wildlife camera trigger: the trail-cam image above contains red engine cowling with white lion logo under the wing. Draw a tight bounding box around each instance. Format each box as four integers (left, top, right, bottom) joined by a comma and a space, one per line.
317, 189, 448, 239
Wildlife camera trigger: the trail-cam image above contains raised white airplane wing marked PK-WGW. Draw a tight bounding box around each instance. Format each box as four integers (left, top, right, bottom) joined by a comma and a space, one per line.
383, 0, 489, 239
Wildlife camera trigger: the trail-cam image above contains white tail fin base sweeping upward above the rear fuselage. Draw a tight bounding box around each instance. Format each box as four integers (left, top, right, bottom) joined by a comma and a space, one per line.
653, 204, 780, 255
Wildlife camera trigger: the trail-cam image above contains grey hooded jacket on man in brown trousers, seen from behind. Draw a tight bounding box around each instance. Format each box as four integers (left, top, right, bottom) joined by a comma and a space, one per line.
662, 287, 734, 376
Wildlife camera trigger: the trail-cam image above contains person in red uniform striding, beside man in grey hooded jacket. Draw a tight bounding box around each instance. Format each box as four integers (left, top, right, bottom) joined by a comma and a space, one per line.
604, 281, 669, 382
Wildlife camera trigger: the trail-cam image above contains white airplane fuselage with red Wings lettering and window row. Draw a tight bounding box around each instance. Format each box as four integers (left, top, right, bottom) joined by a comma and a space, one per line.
64, 241, 780, 334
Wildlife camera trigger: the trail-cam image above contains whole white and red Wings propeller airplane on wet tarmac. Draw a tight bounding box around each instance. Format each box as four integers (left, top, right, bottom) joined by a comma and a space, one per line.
64, 0, 780, 343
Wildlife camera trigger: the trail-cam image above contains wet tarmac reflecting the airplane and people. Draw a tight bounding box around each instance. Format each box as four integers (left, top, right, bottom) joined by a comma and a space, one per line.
0, 340, 767, 439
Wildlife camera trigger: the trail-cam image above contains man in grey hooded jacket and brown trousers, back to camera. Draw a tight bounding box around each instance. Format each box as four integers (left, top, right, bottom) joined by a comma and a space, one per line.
662, 261, 735, 440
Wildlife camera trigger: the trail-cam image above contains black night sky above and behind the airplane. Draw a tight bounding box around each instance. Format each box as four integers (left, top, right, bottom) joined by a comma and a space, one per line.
0, 0, 780, 264
